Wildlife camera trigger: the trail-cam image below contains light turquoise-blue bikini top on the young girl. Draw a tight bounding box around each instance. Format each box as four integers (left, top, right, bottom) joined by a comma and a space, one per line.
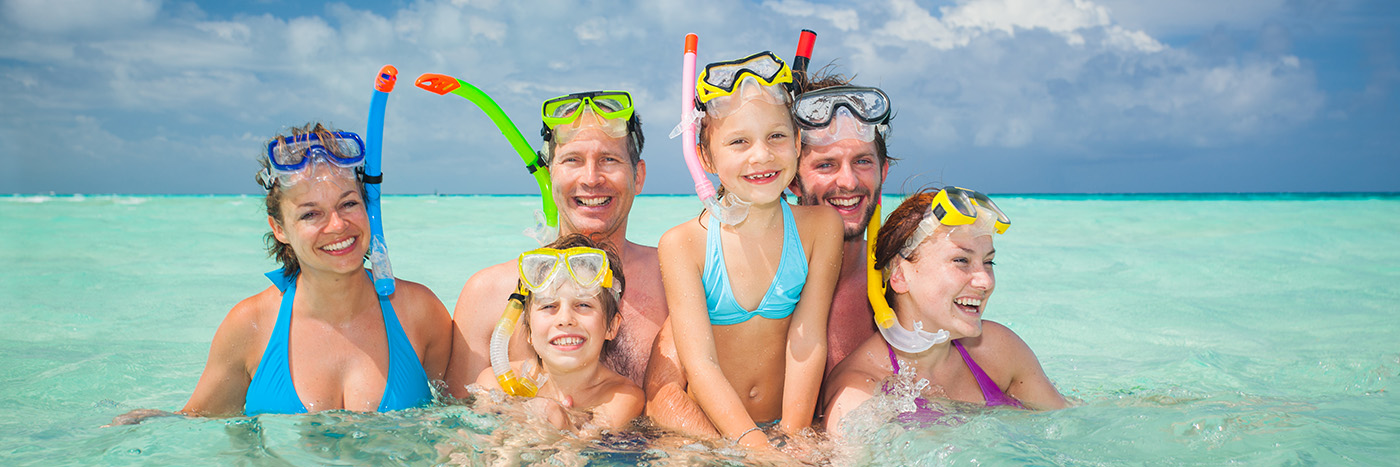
700, 201, 806, 326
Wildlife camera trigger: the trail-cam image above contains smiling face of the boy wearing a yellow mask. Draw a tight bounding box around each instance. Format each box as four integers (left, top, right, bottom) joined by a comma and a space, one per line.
525, 281, 622, 375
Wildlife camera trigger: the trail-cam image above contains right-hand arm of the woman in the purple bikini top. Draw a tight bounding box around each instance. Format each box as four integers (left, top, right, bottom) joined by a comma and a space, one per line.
981, 320, 1068, 410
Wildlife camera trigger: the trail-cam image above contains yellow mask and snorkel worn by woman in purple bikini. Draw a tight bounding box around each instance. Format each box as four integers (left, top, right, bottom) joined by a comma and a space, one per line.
865, 186, 1011, 354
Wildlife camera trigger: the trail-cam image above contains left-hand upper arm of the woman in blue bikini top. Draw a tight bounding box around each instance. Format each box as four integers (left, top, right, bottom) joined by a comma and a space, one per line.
179, 288, 266, 417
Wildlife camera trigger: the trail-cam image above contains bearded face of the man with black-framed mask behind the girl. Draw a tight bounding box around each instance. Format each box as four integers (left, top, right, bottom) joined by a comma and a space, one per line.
790, 138, 889, 242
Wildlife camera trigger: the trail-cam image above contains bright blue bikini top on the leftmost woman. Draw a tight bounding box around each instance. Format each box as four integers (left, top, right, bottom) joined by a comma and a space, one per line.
244, 268, 433, 417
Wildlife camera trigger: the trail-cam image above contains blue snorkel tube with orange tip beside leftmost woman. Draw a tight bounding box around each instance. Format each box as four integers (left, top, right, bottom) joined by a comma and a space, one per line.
364, 64, 399, 296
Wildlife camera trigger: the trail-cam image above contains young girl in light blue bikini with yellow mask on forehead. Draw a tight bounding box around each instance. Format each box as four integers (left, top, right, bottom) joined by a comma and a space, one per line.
647, 52, 841, 449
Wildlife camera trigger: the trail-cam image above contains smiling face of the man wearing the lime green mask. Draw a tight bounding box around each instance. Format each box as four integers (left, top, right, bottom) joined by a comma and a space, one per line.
549, 127, 647, 235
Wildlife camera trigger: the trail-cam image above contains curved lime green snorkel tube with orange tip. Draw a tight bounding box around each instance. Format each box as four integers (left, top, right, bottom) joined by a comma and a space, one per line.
413, 73, 559, 245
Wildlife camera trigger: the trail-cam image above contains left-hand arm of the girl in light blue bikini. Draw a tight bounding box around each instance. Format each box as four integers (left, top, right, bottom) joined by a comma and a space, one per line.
657, 224, 767, 449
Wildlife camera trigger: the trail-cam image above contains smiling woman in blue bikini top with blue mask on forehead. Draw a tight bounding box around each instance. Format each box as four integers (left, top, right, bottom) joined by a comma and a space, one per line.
105, 123, 451, 424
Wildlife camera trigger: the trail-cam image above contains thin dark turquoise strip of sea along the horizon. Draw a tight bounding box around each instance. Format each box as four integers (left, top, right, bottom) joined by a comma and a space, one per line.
0, 192, 1400, 201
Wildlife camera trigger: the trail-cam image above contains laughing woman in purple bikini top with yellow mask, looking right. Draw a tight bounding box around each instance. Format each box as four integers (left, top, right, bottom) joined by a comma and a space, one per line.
825, 187, 1065, 436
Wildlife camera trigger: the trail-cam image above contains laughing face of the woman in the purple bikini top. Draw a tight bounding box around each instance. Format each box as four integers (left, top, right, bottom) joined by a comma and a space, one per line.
889, 225, 997, 338
